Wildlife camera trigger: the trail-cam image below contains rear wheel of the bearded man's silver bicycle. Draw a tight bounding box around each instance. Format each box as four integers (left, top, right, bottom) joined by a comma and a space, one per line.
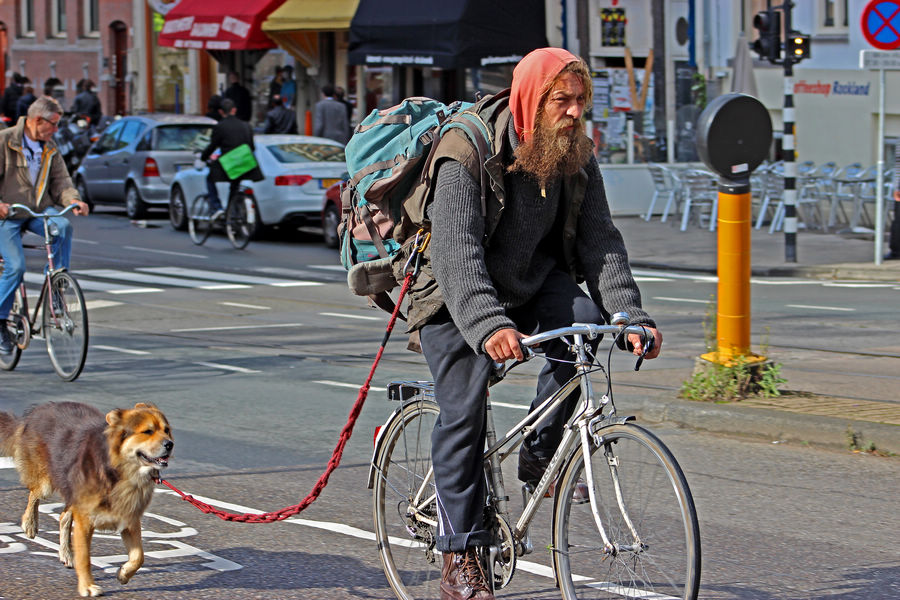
373, 400, 442, 600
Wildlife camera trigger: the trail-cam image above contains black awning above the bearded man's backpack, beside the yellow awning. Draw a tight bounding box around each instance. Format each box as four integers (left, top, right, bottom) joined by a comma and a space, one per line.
348, 0, 547, 69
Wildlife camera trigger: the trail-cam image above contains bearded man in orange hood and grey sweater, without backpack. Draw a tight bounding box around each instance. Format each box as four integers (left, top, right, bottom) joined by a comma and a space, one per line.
409, 48, 662, 600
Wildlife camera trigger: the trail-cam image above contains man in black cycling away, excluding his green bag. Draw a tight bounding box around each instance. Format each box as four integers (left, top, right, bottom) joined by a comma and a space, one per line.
200, 98, 263, 221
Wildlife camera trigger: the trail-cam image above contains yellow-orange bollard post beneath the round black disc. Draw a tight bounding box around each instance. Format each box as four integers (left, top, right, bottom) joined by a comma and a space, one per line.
701, 179, 766, 366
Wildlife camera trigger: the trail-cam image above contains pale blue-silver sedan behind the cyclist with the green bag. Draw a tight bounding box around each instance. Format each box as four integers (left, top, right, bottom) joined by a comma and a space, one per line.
169, 134, 347, 235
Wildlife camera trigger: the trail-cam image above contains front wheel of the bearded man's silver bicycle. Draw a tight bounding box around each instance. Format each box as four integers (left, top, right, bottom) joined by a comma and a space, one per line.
552, 424, 700, 600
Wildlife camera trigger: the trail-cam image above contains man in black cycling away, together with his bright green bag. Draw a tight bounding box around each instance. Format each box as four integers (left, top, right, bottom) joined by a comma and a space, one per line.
200, 98, 263, 220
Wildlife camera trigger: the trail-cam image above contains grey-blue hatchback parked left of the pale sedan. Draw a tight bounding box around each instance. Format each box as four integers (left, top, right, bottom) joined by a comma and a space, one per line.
74, 114, 216, 219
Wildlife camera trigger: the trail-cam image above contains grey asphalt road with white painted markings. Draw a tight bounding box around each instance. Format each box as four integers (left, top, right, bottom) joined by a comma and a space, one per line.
0, 212, 900, 600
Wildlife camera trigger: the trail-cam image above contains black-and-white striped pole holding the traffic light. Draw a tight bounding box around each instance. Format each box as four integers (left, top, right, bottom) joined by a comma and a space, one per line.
781, 0, 797, 262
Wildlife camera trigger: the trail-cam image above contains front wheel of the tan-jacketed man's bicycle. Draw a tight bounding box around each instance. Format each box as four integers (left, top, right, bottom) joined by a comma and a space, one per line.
43, 271, 88, 381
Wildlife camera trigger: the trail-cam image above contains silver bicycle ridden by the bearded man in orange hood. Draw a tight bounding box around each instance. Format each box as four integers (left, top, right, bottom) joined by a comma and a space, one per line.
368, 313, 700, 600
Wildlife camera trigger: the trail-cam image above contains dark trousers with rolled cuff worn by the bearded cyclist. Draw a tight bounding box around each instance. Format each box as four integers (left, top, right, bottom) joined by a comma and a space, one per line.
420, 270, 603, 552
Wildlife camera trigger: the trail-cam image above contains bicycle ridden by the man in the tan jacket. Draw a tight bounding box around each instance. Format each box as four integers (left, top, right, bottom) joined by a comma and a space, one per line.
0, 204, 88, 381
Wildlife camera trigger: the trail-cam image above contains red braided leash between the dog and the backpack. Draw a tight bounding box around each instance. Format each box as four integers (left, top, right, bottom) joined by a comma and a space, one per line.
157, 270, 416, 523
